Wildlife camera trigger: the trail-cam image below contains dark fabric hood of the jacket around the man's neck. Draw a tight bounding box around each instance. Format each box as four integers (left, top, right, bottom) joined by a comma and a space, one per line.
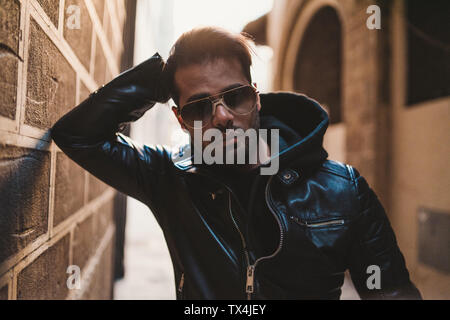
172, 92, 329, 170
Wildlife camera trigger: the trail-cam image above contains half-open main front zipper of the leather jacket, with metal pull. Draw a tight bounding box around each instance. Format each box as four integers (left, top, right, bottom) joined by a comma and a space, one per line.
229, 176, 284, 300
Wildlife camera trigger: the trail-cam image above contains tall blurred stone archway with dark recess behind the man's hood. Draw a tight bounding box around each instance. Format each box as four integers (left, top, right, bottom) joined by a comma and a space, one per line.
281, 0, 346, 162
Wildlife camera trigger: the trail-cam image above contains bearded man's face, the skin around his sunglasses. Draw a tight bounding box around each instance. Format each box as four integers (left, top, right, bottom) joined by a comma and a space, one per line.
173, 58, 261, 158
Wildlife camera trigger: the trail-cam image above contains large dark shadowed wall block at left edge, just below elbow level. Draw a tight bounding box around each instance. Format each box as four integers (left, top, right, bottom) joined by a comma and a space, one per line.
0, 145, 50, 263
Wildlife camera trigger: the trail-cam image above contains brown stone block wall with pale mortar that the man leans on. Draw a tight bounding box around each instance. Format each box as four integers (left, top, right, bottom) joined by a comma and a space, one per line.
0, 0, 133, 299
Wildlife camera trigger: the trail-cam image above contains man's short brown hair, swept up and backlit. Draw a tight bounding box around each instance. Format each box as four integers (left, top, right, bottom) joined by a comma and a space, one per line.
164, 27, 252, 106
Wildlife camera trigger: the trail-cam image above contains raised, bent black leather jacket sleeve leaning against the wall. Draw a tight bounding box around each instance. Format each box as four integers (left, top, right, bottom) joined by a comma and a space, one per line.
51, 54, 170, 208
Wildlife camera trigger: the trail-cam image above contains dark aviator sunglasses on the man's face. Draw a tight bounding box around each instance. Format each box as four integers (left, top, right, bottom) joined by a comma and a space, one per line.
177, 85, 258, 128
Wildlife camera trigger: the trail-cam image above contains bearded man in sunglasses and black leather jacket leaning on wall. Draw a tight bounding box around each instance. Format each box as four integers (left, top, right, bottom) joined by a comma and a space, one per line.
51, 27, 421, 299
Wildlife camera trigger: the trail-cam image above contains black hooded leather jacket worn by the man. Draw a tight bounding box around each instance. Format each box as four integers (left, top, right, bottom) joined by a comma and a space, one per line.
51, 55, 421, 299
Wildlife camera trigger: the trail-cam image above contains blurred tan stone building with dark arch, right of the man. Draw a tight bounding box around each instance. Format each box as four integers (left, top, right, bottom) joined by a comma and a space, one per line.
256, 0, 450, 299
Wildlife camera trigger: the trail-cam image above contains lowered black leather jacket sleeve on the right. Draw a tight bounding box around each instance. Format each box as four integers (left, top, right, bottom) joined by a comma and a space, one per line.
349, 167, 422, 300
